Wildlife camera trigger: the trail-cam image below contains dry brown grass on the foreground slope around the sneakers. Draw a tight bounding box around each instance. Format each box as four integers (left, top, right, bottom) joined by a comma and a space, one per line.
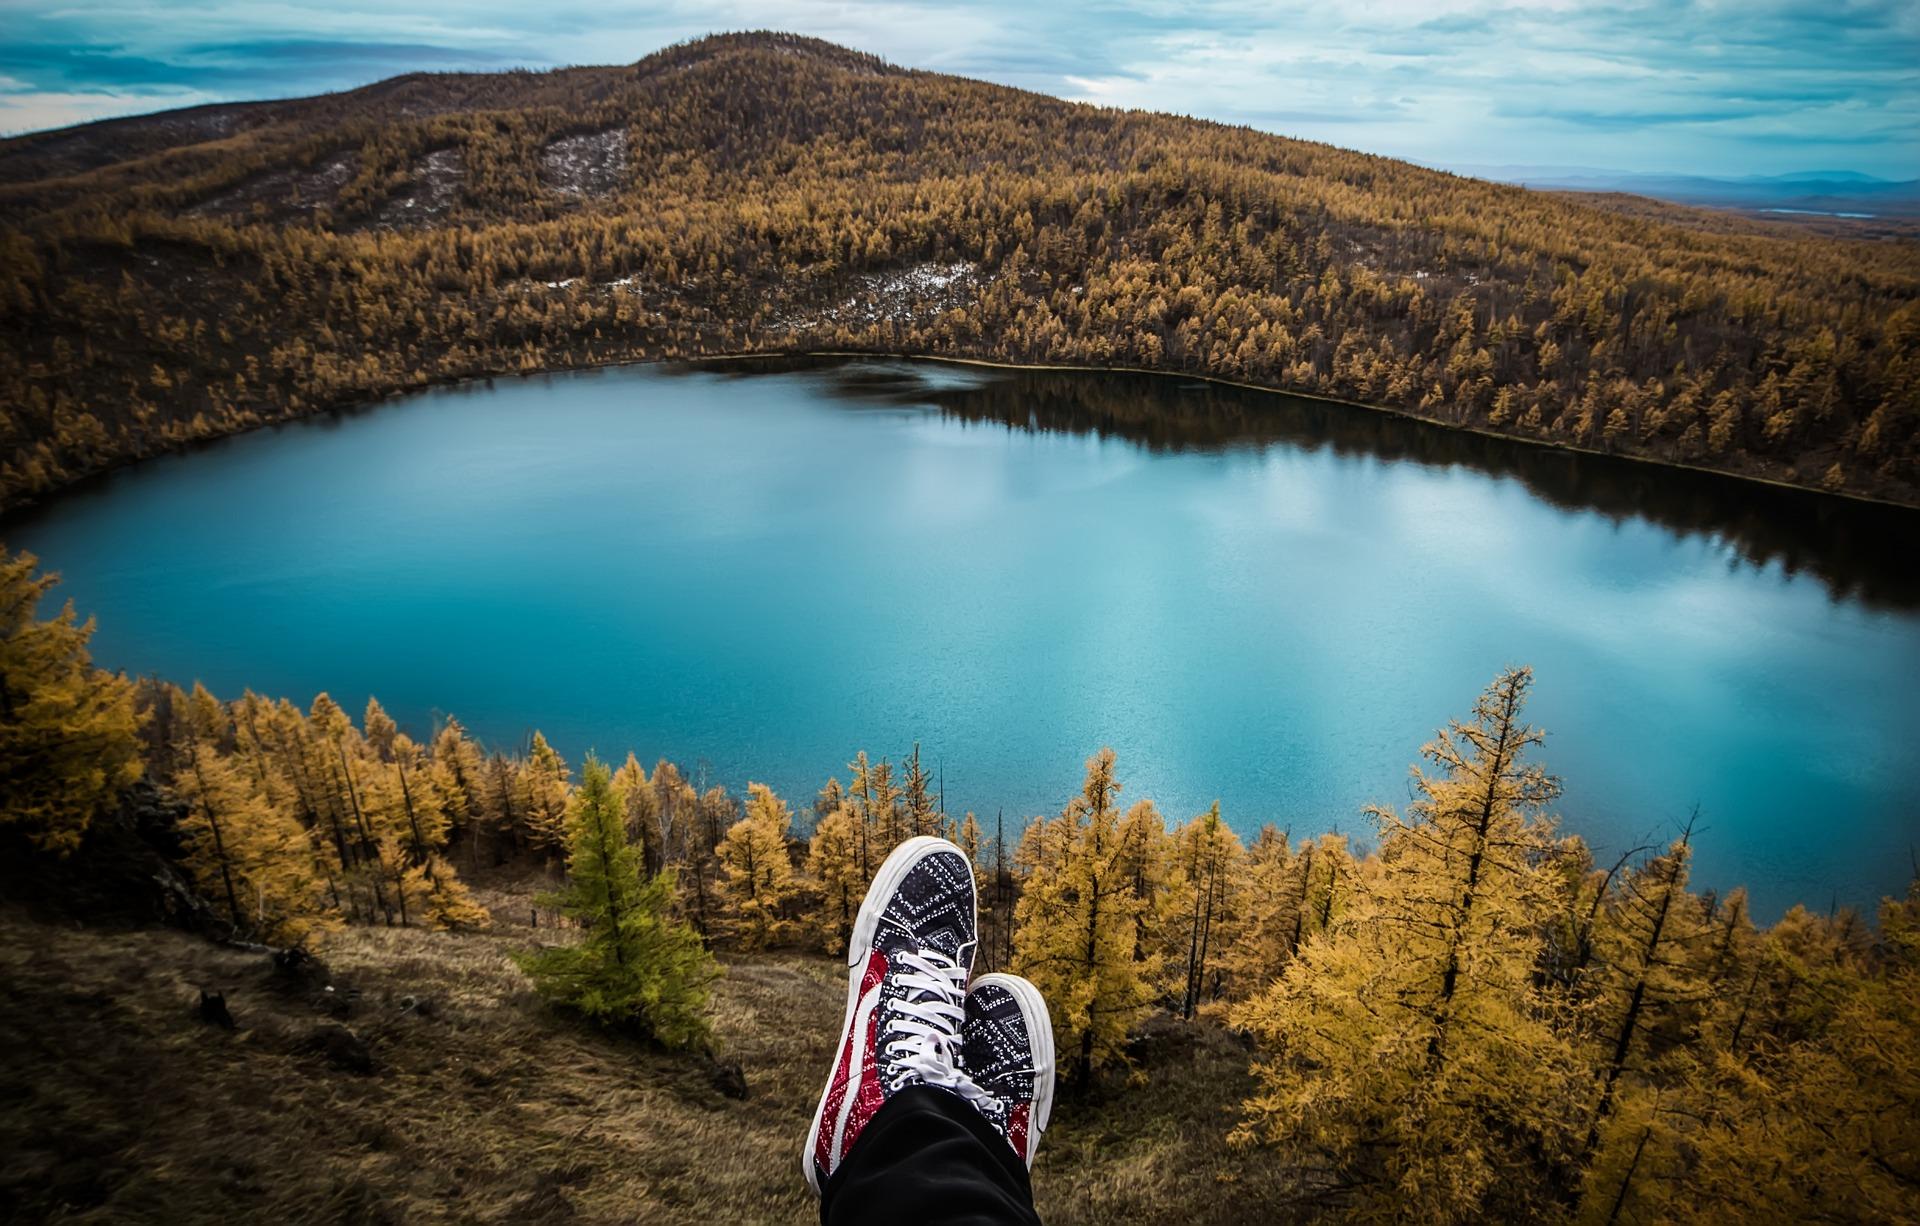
0, 892, 1297, 1224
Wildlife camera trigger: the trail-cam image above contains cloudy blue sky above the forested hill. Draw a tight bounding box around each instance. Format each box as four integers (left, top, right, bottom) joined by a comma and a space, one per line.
0, 0, 1920, 178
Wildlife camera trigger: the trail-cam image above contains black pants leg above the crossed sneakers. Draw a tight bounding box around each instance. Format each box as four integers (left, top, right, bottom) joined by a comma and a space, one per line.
820, 1086, 1041, 1226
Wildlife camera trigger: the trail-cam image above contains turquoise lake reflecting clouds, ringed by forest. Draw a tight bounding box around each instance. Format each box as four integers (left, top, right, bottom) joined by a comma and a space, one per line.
6, 361, 1920, 919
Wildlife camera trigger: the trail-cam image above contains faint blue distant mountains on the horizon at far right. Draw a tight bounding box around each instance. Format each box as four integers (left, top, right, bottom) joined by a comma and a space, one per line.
1446, 165, 1920, 217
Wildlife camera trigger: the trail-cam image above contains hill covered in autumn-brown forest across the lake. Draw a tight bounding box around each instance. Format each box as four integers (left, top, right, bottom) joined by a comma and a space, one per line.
0, 35, 1920, 505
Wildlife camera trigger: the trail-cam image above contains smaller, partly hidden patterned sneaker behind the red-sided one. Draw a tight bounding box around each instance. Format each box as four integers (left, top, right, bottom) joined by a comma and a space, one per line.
960, 975, 1054, 1170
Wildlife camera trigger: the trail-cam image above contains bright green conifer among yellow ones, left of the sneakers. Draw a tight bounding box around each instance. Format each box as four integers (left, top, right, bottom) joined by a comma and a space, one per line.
516, 756, 716, 1048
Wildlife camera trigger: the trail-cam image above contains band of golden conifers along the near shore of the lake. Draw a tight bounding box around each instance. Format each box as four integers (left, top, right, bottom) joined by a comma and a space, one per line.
0, 554, 1920, 1222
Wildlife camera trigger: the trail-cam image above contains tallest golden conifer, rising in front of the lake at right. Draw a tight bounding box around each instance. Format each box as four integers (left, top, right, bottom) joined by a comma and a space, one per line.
1233, 670, 1584, 1222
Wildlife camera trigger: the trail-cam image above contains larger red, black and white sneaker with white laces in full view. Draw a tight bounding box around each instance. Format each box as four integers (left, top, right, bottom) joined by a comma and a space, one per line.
801, 835, 987, 1195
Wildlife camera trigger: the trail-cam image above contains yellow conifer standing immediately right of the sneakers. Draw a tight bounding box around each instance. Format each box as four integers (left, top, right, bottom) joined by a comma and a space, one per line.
1014, 750, 1158, 1084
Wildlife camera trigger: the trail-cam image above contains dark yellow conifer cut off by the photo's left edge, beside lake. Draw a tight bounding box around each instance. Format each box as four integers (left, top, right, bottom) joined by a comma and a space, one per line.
0, 553, 140, 856
